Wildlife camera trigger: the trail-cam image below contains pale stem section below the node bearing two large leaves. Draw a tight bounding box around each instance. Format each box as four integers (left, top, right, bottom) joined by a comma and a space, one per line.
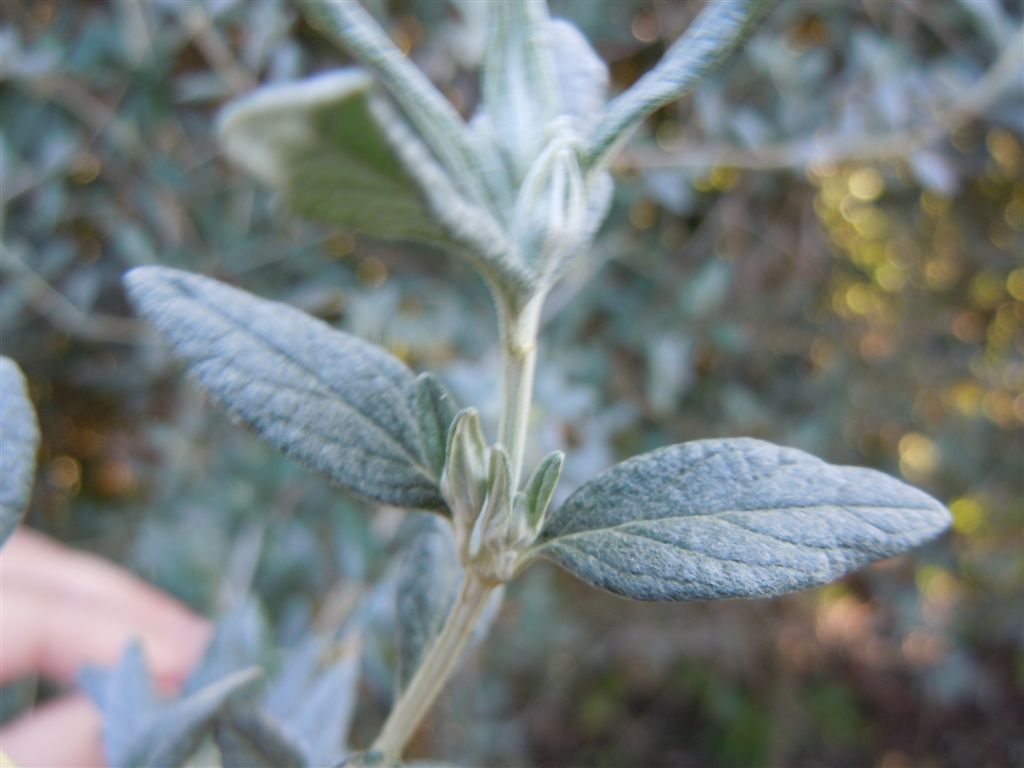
370, 570, 496, 764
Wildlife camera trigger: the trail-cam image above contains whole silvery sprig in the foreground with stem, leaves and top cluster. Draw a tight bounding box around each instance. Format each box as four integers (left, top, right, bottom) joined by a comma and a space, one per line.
127, 0, 949, 762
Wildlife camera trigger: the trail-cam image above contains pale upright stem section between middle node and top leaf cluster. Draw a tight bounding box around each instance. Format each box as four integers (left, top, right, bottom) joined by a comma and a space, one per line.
498, 293, 545, 489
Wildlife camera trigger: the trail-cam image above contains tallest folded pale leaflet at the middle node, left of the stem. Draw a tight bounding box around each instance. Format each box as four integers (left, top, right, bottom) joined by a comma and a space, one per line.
441, 408, 487, 529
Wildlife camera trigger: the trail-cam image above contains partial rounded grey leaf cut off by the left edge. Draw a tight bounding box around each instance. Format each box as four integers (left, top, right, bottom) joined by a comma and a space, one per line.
0, 357, 39, 546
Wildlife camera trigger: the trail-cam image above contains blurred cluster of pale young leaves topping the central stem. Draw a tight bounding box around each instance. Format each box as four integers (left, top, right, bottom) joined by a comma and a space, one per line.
220, 0, 771, 303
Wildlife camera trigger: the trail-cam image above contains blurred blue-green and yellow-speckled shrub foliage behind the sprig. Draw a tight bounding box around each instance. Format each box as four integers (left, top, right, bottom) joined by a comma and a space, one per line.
0, 0, 1024, 768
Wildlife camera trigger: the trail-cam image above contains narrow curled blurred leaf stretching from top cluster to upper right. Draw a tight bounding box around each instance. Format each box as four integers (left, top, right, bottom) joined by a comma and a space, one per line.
587, 0, 774, 167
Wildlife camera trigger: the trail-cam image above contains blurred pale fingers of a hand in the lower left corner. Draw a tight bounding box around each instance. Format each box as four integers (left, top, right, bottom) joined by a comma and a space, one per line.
0, 528, 210, 768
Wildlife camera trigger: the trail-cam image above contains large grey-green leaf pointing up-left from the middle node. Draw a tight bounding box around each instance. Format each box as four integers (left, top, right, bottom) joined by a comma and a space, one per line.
126, 267, 444, 510
